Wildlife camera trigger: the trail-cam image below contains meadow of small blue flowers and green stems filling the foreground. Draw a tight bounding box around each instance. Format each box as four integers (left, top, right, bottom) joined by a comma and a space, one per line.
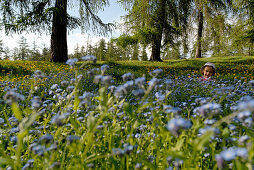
0, 56, 254, 170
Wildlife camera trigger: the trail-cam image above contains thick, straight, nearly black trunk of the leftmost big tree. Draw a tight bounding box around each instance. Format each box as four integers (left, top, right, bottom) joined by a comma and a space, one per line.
50, 0, 68, 62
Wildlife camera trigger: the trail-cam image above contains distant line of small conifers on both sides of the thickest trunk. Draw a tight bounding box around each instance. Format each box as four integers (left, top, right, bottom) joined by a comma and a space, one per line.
0, 36, 148, 61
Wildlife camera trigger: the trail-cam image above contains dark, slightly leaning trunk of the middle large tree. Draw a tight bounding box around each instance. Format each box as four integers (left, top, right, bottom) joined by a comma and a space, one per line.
150, 0, 166, 61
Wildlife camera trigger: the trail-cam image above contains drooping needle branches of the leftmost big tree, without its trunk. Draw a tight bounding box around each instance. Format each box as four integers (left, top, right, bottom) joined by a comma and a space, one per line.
0, 0, 113, 33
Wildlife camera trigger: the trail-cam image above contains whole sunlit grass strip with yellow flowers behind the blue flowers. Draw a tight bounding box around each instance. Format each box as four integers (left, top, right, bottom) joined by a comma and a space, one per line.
0, 56, 254, 81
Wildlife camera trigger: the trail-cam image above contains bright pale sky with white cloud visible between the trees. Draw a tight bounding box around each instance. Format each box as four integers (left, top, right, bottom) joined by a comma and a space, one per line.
0, 0, 126, 54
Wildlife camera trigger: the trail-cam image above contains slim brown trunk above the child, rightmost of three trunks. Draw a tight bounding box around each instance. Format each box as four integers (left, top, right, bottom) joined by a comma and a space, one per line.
195, 9, 203, 58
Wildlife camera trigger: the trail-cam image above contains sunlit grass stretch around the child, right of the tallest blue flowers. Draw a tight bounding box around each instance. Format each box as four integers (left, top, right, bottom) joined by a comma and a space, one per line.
90, 57, 254, 80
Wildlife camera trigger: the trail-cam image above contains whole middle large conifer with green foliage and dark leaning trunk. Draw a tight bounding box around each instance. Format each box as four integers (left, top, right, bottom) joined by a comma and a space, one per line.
118, 0, 191, 61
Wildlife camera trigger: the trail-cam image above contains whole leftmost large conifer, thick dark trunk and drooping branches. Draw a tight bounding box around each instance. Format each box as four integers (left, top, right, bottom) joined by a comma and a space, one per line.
0, 0, 113, 62
